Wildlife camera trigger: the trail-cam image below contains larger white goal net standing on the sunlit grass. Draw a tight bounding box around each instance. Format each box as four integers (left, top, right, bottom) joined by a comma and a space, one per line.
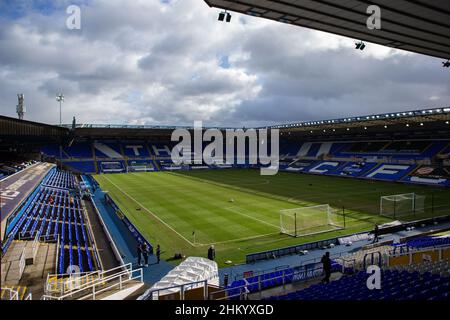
280, 204, 344, 237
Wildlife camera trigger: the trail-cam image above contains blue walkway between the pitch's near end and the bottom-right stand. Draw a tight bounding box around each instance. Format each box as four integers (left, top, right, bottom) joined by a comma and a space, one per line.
219, 223, 450, 284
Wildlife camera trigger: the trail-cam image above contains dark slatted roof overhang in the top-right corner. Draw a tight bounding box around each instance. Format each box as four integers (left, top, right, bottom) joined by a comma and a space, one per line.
204, 0, 450, 59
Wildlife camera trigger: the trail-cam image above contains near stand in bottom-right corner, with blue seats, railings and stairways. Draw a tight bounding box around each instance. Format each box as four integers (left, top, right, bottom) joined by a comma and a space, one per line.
260, 232, 450, 300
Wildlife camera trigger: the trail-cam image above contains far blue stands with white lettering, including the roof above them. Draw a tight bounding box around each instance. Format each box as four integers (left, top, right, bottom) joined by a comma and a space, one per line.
32, 108, 450, 186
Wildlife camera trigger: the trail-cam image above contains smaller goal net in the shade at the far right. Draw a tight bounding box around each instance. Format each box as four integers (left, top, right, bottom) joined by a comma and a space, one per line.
380, 193, 425, 218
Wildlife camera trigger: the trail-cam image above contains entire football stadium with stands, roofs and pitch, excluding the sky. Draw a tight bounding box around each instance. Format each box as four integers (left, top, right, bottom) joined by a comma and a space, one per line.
0, 0, 450, 308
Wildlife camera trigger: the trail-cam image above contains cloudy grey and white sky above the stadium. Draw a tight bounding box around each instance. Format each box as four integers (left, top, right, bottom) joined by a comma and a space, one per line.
0, 0, 450, 126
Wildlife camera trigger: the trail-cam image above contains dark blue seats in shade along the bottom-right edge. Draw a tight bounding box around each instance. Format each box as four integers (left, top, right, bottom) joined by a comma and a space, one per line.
269, 270, 450, 300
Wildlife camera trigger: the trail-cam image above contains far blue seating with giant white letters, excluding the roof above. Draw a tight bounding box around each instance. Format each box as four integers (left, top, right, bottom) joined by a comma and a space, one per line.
41, 138, 450, 186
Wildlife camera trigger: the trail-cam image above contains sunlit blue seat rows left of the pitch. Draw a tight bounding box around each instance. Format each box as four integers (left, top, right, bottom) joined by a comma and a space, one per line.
7, 169, 95, 274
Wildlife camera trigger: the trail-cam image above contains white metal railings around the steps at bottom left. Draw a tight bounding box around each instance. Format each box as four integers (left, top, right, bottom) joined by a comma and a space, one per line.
42, 263, 144, 300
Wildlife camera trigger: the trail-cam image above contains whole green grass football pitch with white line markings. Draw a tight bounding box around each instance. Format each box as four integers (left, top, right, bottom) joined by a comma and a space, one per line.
95, 170, 450, 266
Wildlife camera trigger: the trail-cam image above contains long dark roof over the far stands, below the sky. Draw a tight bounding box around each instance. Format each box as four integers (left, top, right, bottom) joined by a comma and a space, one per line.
0, 107, 450, 143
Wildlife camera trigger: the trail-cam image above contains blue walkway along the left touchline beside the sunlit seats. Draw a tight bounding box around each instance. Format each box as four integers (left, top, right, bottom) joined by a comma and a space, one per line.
83, 179, 174, 286
